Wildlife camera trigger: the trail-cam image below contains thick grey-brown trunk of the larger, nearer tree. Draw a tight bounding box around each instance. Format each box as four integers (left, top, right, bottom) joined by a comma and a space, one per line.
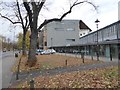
28, 4, 39, 67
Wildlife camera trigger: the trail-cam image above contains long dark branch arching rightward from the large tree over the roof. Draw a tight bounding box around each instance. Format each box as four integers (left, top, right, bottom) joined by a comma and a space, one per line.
37, 0, 97, 31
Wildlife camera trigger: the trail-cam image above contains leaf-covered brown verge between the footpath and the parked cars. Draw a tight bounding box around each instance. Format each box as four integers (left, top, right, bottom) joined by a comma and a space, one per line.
13, 54, 103, 72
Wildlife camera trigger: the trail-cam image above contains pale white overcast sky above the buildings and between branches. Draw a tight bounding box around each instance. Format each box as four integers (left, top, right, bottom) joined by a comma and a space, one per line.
0, 0, 120, 39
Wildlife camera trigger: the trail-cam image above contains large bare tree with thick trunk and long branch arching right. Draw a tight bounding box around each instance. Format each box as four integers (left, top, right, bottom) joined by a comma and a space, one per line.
23, 0, 96, 66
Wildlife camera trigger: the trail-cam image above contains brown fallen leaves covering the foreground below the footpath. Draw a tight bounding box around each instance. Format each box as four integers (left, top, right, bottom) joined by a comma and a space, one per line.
11, 66, 118, 88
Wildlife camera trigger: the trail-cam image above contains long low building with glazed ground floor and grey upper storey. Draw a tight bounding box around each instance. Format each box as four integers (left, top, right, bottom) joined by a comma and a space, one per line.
54, 20, 120, 61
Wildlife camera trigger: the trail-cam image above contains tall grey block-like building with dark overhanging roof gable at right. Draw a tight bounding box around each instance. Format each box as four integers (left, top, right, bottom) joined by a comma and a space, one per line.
42, 20, 91, 49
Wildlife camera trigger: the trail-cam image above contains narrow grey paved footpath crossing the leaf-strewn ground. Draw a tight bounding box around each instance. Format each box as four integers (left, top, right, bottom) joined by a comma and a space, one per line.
11, 62, 118, 85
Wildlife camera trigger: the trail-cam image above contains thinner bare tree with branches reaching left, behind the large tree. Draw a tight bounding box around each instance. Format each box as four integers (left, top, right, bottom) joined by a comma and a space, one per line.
0, 0, 29, 55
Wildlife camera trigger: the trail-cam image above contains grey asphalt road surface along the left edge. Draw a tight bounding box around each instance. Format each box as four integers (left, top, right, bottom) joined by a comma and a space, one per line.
0, 51, 16, 89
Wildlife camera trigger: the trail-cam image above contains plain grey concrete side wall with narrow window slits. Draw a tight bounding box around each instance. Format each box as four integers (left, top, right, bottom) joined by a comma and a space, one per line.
46, 20, 79, 47
